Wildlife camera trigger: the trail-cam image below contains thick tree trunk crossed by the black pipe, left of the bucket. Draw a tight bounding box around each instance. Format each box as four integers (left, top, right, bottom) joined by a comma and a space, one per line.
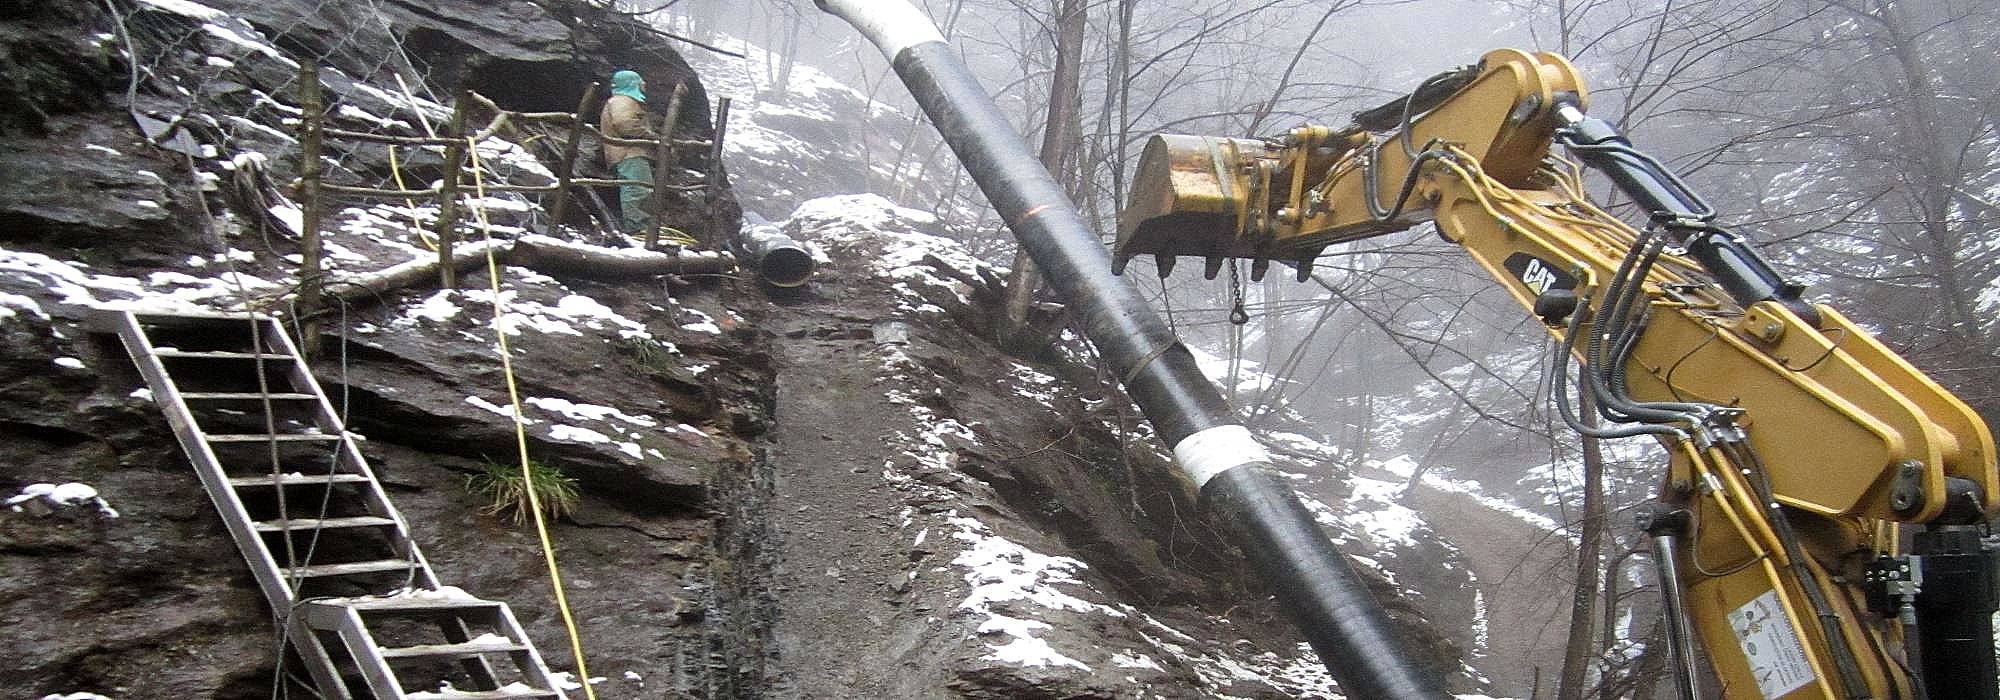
1000, 0, 1086, 352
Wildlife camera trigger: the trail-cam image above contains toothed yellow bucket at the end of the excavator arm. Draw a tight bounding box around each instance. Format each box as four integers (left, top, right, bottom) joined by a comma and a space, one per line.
1112, 134, 1266, 278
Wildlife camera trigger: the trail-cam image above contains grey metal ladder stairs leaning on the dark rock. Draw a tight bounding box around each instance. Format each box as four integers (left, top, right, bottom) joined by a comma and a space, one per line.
88, 310, 564, 700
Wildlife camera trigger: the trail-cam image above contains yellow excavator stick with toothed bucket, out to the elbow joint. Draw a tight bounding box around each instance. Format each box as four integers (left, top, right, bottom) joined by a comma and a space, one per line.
1112, 50, 1588, 282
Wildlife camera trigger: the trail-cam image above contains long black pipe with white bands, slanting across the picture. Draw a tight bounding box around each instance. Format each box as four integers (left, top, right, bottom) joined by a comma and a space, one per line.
816, 0, 1446, 700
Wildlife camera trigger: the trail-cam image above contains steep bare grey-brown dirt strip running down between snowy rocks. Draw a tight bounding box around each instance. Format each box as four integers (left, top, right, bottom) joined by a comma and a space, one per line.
768, 312, 960, 698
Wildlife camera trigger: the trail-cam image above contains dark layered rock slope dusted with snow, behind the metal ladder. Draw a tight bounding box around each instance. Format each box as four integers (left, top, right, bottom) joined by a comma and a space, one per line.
0, 0, 1472, 698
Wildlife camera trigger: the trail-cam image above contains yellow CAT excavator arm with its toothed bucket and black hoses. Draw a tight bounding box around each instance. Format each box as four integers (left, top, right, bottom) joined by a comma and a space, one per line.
1112, 50, 2000, 700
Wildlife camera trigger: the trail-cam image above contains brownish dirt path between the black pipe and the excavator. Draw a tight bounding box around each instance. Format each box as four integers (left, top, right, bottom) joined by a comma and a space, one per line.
1410, 478, 1576, 698
